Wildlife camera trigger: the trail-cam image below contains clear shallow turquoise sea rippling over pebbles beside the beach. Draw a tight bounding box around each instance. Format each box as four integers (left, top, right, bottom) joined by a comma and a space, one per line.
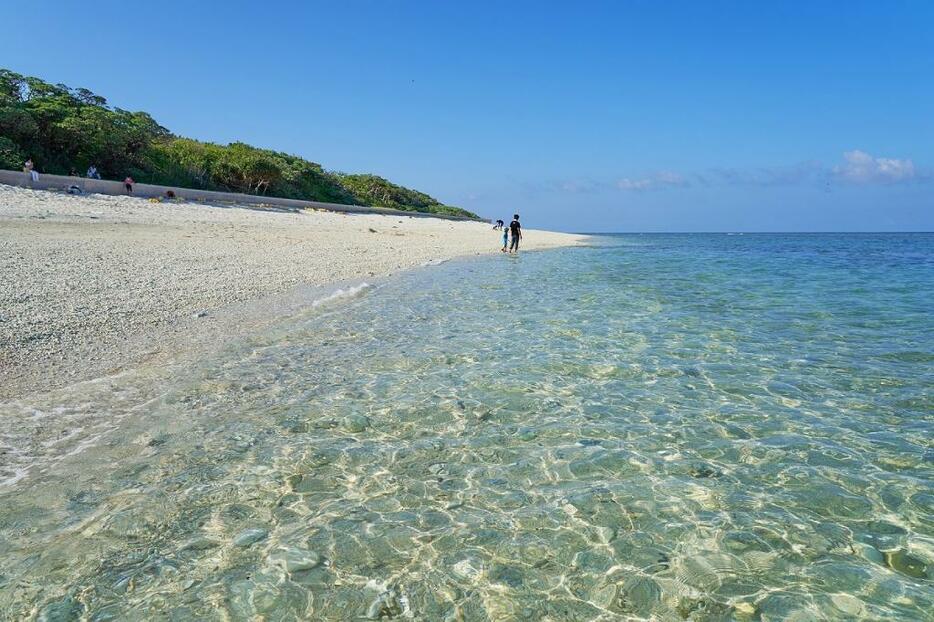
0, 234, 934, 620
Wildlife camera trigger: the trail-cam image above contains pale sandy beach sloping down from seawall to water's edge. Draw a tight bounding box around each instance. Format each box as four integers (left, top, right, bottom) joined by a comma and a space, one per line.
0, 186, 586, 397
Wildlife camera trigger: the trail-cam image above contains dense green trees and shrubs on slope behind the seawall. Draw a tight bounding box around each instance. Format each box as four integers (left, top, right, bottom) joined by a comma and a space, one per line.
0, 69, 476, 218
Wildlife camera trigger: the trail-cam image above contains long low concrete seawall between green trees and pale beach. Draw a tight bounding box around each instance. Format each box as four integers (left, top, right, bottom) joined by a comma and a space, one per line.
0, 169, 482, 220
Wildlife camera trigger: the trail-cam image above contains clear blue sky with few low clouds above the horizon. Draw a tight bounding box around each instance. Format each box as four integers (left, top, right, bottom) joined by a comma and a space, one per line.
0, 0, 934, 231
